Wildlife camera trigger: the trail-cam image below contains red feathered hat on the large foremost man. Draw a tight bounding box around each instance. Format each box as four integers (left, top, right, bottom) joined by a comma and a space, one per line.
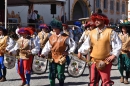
91, 9, 109, 25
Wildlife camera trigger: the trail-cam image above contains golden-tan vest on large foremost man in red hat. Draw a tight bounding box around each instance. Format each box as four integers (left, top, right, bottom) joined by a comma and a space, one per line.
89, 28, 112, 60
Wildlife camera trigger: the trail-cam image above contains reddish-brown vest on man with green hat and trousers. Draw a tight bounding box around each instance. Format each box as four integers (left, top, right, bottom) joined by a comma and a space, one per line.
49, 33, 68, 63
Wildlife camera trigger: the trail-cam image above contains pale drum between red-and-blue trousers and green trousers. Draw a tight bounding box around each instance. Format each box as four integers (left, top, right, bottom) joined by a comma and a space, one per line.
32, 55, 48, 74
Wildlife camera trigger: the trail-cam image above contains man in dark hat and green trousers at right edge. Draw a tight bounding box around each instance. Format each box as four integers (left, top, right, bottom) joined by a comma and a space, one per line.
118, 21, 130, 84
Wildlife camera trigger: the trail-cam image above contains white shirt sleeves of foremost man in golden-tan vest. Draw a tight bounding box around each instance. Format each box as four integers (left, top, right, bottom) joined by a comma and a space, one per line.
78, 28, 122, 57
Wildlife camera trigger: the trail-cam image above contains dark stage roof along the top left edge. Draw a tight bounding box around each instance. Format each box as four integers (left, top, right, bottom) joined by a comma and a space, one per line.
7, 0, 66, 6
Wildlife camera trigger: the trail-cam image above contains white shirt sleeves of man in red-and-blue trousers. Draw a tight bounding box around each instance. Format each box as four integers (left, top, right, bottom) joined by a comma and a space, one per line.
10, 37, 40, 55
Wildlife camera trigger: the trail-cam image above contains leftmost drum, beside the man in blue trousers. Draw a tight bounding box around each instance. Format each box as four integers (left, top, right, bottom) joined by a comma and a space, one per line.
4, 54, 16, 69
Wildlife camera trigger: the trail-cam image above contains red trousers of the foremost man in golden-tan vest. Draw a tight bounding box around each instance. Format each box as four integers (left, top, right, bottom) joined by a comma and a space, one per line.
89, 63, 114, 86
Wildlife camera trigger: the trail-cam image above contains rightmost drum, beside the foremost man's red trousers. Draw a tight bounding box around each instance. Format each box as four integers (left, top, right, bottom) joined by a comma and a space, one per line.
68, 54, 86, 77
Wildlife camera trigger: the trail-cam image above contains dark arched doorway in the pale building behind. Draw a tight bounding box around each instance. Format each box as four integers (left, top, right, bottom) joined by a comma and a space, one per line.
71, 0, 91, 19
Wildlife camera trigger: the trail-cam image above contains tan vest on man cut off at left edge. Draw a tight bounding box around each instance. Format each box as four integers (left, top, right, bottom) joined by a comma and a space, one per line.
0, 36, 8, 56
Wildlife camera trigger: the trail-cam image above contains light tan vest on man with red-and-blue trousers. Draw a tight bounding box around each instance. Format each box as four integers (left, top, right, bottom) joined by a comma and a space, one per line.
17, 38, 31, 59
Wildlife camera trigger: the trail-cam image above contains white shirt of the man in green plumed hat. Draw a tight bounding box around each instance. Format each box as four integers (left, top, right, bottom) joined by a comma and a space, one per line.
41, 32, 77, 56
